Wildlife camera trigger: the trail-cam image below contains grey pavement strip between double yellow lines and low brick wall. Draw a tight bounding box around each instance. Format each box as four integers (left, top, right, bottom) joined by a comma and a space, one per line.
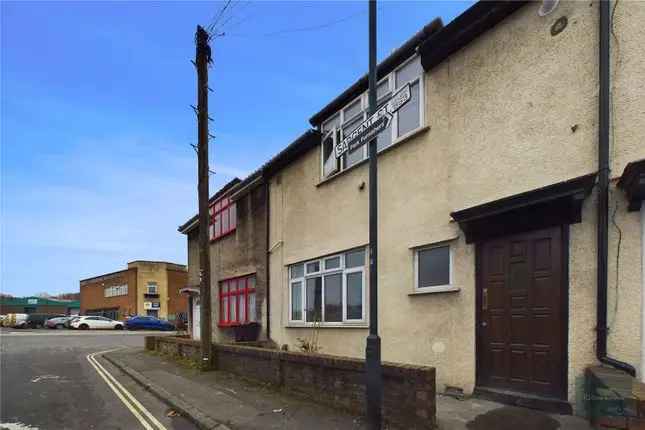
105, 348, 366, 430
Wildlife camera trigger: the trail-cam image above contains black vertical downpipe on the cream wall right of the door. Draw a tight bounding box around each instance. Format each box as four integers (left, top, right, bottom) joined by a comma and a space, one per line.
596, 0, 636, 376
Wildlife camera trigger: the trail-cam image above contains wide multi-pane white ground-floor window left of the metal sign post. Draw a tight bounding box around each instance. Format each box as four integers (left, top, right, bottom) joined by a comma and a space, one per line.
289, 248, 366, 326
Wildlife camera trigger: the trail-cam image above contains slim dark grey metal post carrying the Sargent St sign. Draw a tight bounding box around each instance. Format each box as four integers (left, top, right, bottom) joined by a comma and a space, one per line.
365, 0, 383, 430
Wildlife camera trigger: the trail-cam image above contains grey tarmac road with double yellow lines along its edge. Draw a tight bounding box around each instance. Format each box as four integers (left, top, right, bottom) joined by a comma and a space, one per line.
0, 328, 196, 430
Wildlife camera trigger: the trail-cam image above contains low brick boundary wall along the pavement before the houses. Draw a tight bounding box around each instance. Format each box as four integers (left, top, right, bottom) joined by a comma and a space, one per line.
145, 336, 436, 429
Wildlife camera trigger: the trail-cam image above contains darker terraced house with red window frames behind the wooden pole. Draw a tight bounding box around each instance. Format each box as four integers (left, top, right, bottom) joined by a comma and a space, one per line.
178, 175, 269, 341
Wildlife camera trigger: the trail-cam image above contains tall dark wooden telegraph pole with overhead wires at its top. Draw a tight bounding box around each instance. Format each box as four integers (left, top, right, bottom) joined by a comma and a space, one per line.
195, 25, 212, 370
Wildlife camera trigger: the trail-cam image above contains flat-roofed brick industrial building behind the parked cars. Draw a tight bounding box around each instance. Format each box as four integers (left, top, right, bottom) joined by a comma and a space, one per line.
80, 260, 188, 321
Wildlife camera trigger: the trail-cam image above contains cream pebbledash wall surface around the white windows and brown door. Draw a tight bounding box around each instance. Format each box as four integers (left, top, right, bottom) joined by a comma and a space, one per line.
269, 1, 645, 408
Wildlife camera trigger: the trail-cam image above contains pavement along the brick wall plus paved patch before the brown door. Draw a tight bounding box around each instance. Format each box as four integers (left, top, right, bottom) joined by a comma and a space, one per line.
105, 348, 591, 430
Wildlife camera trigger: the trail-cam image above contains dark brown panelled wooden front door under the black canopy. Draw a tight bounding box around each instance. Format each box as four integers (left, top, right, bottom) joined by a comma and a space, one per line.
477, 227, 567, 398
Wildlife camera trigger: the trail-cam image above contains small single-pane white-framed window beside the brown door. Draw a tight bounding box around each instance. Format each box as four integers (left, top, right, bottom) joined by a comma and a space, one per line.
414, 242, 454, 292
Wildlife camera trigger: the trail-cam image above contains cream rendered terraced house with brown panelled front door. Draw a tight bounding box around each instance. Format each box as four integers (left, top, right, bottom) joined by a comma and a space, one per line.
182, 1, 645, 411
